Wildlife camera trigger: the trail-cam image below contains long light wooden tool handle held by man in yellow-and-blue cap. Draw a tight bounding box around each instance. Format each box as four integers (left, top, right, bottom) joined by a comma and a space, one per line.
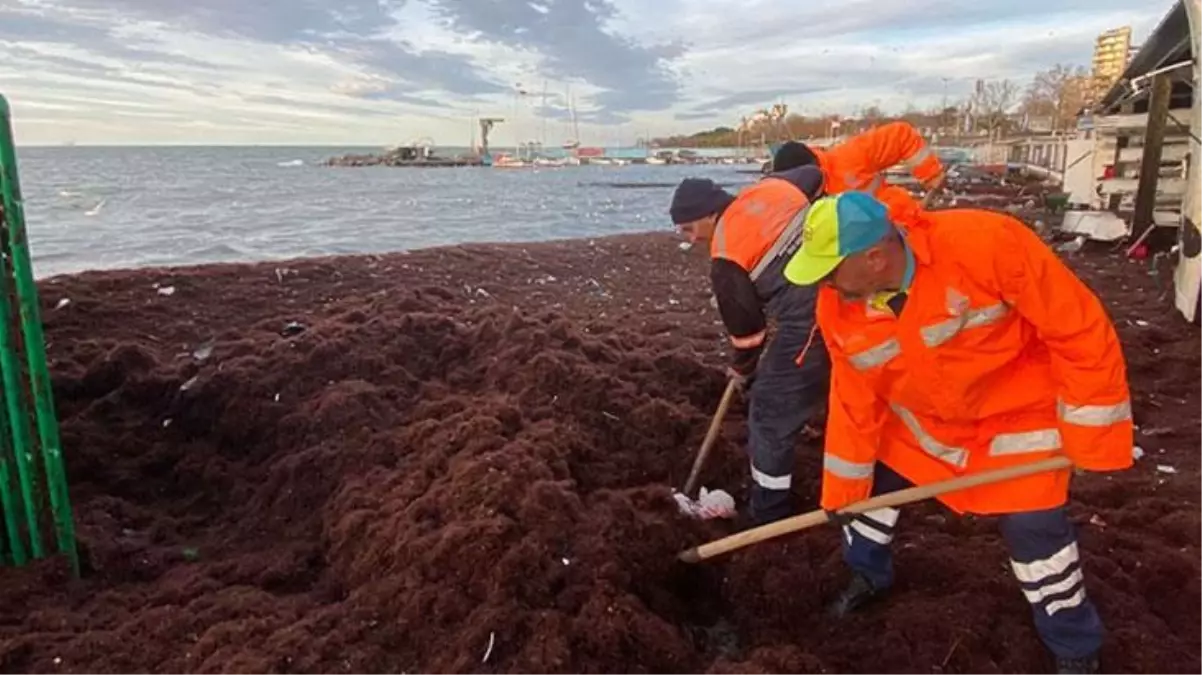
678, 455, 1072, 562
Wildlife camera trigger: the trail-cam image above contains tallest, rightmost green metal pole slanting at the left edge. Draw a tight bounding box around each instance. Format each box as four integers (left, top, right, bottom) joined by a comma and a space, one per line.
0, 95, 79, 577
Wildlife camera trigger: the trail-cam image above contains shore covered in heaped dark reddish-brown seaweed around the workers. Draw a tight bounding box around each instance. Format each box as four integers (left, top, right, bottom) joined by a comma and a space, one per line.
0, 230, 1202, 675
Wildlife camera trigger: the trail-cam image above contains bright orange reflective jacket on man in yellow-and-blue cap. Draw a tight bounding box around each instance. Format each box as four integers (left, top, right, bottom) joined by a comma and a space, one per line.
817, 209, 1133, 514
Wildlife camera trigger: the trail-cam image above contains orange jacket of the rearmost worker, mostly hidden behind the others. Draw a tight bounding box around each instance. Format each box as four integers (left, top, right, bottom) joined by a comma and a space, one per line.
811, 121, 944, 195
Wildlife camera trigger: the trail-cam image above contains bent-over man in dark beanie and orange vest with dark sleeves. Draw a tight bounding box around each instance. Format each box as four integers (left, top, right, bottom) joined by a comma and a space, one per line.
670, 167, 829, 525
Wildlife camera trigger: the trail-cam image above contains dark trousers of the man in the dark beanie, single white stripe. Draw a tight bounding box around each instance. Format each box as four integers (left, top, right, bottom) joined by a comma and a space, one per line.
748, 317, 831, 524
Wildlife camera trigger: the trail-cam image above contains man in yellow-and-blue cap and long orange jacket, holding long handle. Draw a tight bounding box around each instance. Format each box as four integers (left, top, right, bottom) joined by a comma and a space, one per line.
785, 192, 1132, 675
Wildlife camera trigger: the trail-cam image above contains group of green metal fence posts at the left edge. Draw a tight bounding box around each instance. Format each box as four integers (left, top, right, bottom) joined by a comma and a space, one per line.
0, 95, 79, 577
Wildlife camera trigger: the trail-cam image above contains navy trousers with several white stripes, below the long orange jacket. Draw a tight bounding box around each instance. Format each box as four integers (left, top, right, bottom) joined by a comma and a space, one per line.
843, 462, 1103, 658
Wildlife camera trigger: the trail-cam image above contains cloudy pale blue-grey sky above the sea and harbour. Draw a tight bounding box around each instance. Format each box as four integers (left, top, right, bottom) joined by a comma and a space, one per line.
0, 0, 1173, 147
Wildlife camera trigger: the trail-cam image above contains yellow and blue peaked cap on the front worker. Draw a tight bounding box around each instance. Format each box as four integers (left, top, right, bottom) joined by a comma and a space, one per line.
785, 192, 893, 286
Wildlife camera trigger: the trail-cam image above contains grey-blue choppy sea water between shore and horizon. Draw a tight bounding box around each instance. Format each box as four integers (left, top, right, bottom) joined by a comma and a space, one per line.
11, 147, 757, 279
